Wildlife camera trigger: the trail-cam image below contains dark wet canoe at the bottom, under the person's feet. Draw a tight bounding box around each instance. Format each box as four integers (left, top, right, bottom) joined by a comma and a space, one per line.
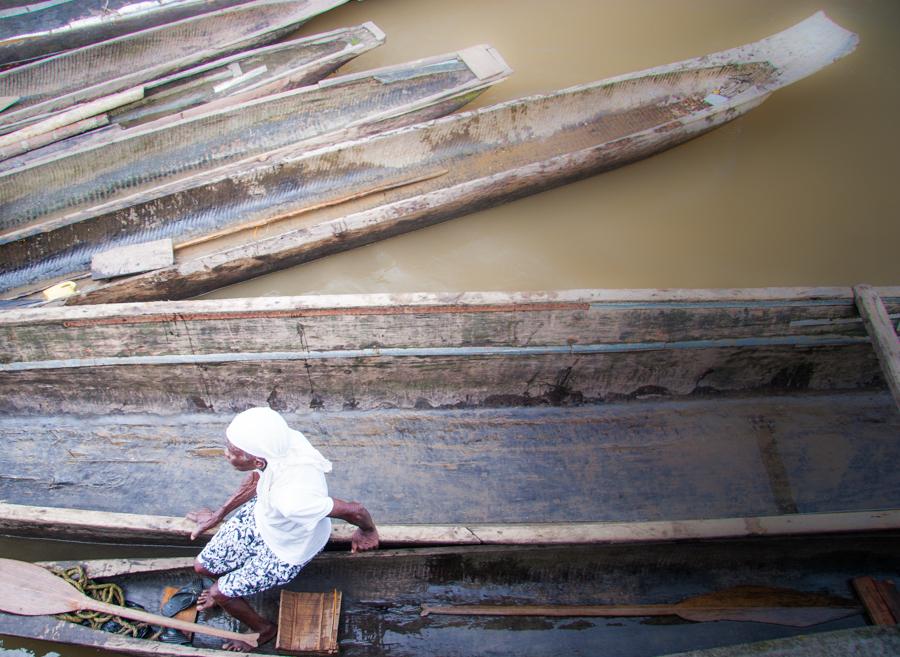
0, 535, 900, 657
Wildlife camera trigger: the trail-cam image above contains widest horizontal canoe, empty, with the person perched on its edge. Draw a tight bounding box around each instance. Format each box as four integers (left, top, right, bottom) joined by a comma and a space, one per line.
0, 288, 900, 544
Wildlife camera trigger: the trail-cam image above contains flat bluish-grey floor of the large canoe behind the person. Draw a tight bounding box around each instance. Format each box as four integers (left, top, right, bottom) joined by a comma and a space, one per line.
0, 394, 900, 526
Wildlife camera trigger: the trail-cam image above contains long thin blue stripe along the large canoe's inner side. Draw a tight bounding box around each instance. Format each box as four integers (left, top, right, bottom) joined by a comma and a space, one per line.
0, 336, 869, 372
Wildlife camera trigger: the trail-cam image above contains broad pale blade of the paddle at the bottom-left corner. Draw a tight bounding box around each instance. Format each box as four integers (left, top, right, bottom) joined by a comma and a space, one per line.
0, 559, 85, 616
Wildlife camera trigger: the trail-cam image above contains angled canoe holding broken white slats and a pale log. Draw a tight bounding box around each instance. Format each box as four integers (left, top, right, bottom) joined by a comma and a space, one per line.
0, 23, 384, 163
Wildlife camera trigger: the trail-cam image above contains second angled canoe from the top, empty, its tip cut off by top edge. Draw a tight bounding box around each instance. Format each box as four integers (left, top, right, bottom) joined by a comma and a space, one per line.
0, 0, 346, 132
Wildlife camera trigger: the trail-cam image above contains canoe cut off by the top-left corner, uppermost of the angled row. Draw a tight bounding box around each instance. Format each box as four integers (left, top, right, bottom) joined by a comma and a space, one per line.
0, 0, 260, 65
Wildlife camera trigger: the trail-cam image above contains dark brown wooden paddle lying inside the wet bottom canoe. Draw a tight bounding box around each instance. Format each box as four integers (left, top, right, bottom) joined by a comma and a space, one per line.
422, 586, 861, 627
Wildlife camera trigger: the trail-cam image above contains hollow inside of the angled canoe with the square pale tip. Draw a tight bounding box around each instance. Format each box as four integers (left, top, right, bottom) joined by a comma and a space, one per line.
0, 44, 502, 229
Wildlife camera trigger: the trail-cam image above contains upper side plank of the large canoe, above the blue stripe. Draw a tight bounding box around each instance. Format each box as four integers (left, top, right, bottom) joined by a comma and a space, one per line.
0, 290, 900, 362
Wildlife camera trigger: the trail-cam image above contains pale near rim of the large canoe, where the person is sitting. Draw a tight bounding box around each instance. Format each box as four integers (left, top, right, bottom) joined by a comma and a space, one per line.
7, 502, 900, 548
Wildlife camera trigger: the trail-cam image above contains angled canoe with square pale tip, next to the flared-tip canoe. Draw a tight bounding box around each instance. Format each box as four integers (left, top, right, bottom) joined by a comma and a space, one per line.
0, 45, 510, 296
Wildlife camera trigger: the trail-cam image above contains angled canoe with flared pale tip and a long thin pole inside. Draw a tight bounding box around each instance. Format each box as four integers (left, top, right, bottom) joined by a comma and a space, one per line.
0, 13, 856, 303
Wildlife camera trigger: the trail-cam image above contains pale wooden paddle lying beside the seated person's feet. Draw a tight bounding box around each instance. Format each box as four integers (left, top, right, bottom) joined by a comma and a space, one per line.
0, 559, 259, 648
